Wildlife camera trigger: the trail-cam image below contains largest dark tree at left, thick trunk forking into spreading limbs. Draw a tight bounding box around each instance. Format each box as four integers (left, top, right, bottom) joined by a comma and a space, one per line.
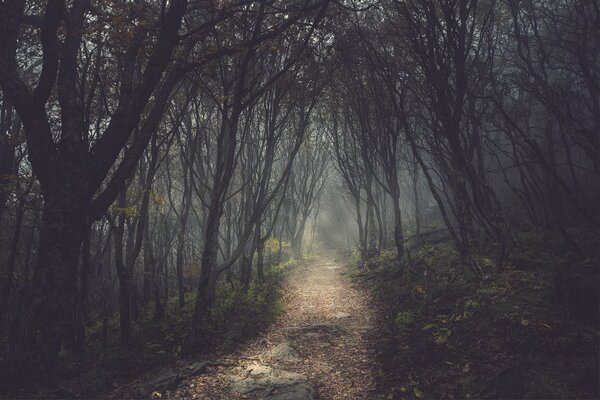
0, 0, 187, 368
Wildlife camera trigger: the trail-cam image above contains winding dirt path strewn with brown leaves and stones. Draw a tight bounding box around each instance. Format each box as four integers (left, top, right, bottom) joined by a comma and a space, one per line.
167, 260, 377, 400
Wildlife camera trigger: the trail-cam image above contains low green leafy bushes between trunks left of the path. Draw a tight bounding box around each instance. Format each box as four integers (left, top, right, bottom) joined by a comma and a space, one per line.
87, 261, 296, 359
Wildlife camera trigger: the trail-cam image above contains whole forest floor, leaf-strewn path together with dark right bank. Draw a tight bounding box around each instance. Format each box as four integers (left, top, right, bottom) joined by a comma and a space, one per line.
8, 236, 600, 400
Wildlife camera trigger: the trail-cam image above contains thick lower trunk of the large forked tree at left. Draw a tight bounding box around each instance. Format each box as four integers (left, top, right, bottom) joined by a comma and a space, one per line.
24, 190, 87, 374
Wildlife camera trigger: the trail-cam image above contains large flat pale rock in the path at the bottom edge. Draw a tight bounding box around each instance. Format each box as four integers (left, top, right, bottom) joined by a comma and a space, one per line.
229, 365, 318, 400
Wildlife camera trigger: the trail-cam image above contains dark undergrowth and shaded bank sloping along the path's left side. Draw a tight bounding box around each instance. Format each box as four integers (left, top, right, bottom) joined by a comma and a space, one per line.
52, 260, 296, 396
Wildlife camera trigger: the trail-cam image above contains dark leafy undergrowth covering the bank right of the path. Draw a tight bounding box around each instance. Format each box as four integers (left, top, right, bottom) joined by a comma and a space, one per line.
353, 228, 600, 399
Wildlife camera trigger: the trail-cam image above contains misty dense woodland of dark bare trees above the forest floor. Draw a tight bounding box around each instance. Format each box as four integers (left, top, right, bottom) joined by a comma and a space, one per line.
0, 0, 600, 398
